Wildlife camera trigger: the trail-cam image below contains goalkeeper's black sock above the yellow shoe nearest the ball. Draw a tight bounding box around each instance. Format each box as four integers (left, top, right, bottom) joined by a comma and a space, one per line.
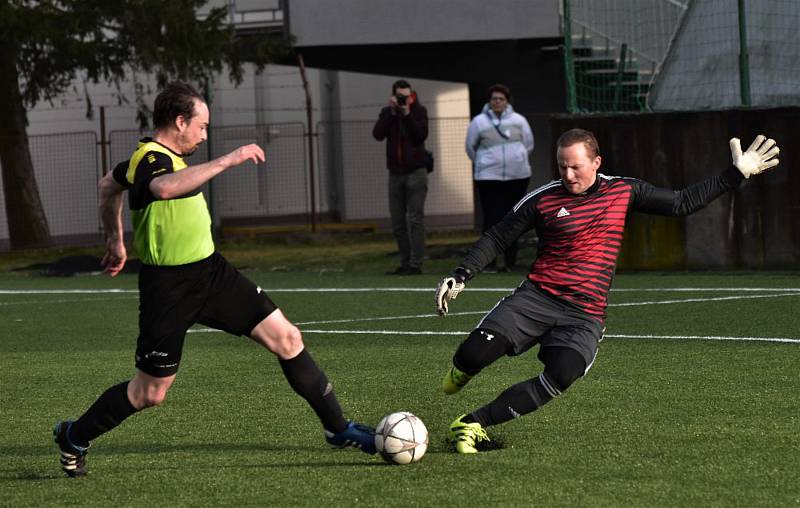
464, 373, 557, 427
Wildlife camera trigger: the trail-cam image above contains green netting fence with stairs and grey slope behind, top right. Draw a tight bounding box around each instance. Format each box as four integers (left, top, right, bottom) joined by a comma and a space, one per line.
562, 0, 800, 112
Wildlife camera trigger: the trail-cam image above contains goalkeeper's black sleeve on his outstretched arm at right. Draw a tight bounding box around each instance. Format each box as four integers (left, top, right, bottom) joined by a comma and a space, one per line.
633, 166, 744, 217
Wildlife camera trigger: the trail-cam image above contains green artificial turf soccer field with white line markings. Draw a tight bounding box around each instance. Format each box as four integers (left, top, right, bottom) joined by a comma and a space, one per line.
0, 271, 800, 507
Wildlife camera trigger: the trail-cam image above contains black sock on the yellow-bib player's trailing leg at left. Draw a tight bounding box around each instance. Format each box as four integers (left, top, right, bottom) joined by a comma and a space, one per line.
69, 381, 137, 446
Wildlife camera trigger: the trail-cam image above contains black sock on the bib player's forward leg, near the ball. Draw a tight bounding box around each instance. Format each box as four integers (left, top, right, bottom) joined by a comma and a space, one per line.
279, 349, 347, 434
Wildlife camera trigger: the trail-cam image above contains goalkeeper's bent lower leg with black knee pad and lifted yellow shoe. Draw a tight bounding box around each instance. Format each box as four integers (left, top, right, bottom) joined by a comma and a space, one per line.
442, 328, 512, 395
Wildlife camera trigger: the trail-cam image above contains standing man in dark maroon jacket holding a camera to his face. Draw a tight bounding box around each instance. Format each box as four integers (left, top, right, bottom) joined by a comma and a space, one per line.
372, 79, 428, 275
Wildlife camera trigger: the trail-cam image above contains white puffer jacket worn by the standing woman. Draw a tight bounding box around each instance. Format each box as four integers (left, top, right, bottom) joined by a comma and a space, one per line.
466, 104, 533, 180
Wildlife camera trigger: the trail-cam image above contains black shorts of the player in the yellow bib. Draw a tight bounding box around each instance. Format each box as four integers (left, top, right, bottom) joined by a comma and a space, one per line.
136, 252, 277, 377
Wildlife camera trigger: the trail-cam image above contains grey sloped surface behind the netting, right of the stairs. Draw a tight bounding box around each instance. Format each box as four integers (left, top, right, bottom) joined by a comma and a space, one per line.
648, 0, 800, 110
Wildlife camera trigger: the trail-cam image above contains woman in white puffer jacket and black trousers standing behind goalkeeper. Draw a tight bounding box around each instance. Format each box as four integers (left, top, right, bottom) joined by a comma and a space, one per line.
466, 85, 533, 271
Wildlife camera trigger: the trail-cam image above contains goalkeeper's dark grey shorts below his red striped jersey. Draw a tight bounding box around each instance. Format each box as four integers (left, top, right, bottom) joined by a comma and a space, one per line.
476, 279, 603, 371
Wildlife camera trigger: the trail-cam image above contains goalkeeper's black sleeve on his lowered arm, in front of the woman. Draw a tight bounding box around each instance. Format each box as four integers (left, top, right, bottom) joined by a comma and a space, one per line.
461, 194, 538, 274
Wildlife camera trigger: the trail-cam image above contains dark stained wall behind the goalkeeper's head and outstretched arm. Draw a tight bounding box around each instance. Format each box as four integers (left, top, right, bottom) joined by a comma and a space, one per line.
550, 108, 800, 270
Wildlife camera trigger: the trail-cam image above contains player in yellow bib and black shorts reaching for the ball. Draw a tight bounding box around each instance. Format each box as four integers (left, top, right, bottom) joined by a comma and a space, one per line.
53, 82, 375, 477
